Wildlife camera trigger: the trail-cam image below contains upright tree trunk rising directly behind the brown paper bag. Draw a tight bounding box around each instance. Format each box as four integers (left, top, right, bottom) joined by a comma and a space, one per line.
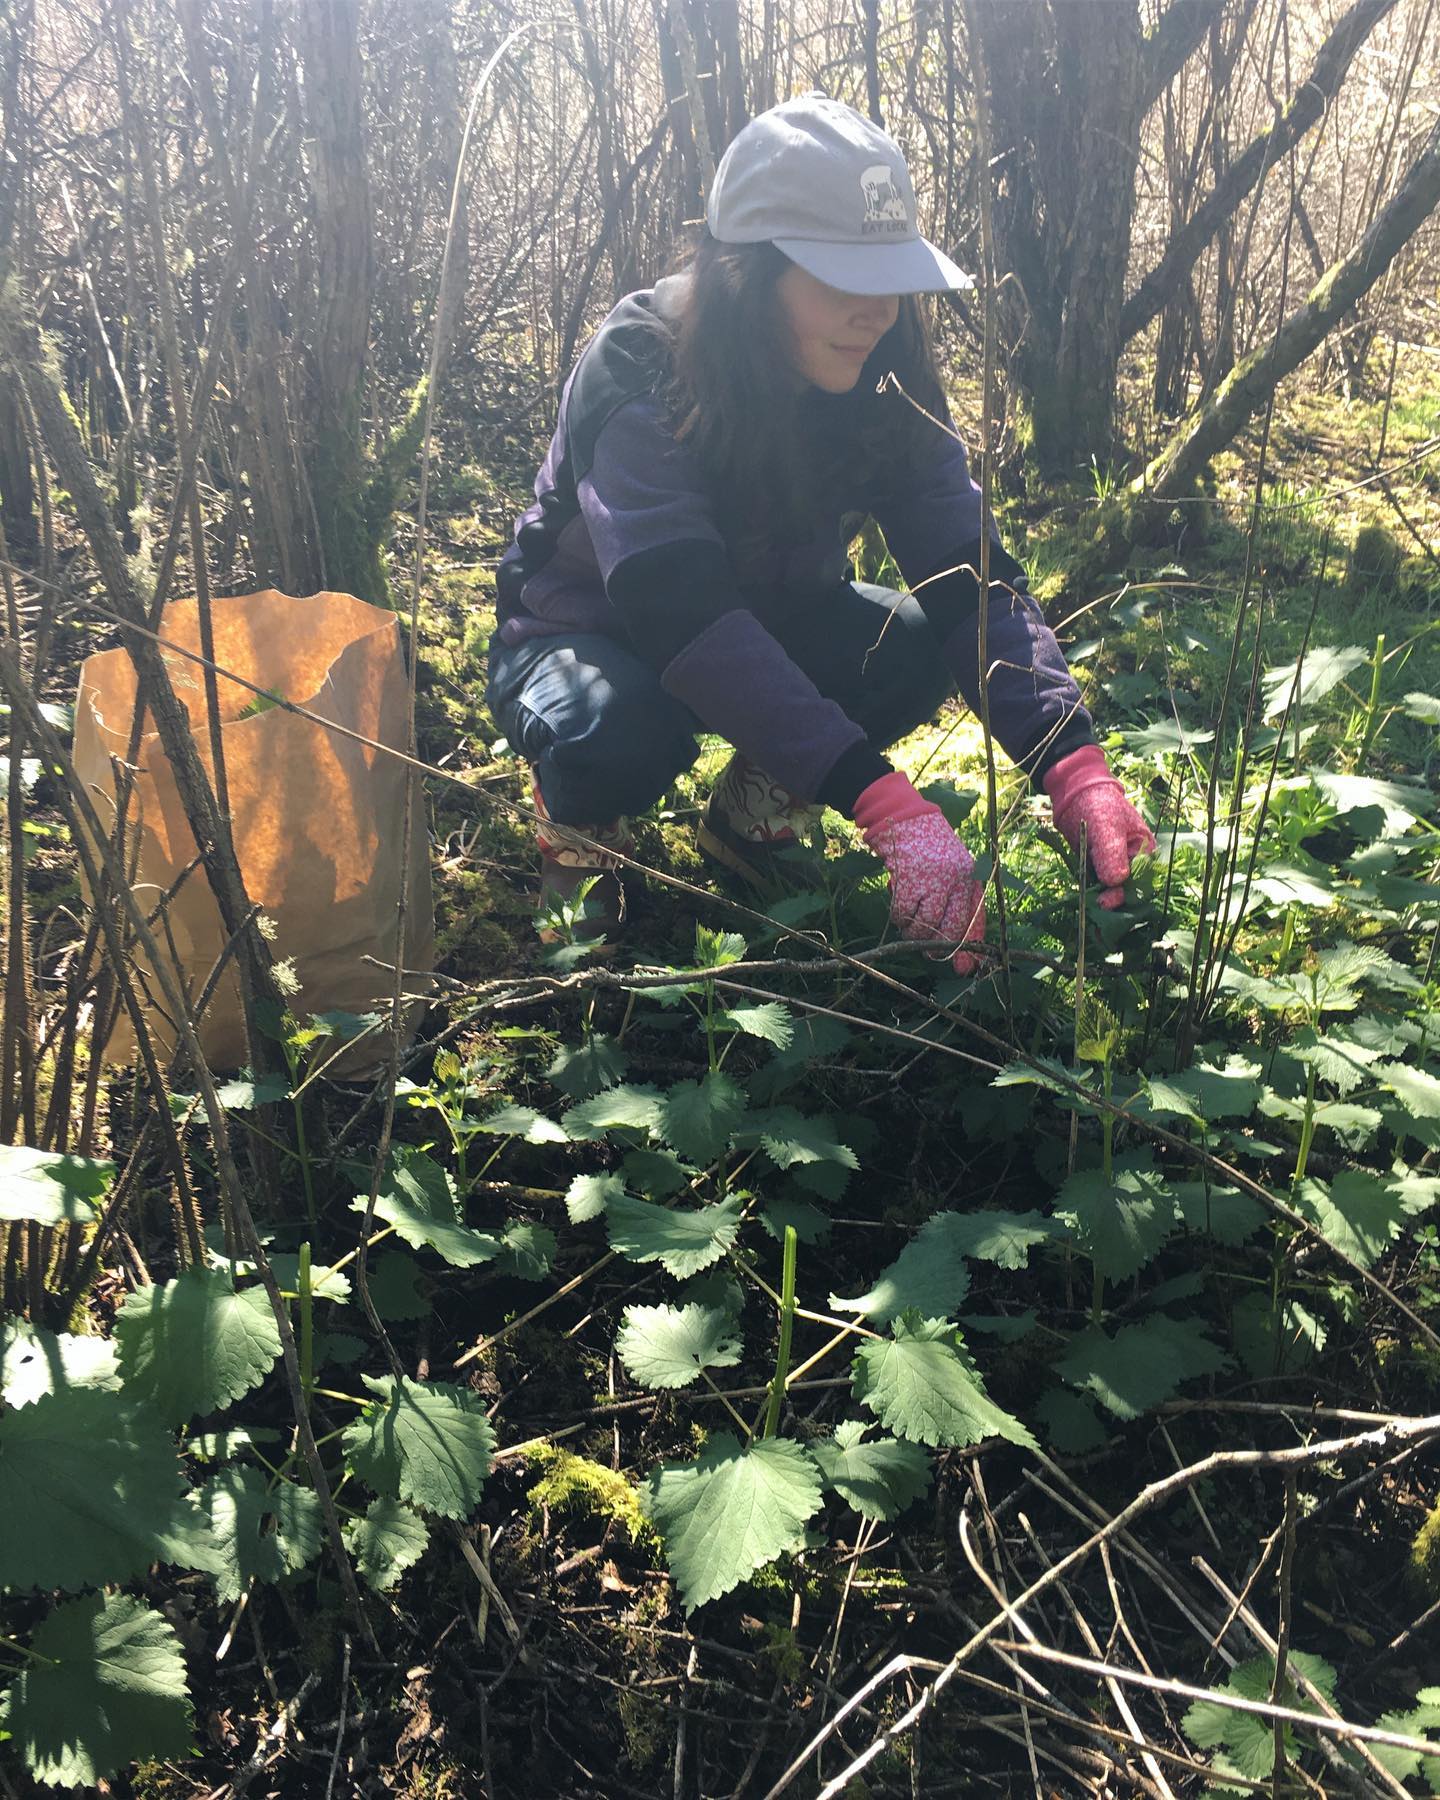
295, 0, 370, 601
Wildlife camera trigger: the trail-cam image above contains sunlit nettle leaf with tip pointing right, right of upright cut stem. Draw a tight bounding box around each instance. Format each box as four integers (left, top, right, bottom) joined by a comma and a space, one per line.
853, 1312, 1035, 1449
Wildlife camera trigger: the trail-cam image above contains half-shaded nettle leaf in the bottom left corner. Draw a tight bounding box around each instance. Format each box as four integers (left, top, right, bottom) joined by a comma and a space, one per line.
0, 1593, 191, 1787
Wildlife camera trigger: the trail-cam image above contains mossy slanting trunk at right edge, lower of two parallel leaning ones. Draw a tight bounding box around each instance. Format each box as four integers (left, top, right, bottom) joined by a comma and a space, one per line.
1134, 111, 1440, 500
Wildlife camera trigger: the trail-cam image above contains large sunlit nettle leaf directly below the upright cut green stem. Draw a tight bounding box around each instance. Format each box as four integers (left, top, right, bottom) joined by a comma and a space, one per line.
641, 1431, 821, 1613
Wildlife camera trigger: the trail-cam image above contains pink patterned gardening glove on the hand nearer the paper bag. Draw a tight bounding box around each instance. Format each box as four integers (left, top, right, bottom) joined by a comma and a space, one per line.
855, 770, 985, 976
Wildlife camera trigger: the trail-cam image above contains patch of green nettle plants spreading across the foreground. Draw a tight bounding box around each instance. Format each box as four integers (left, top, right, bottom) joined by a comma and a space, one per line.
0, 637, 1440, 1786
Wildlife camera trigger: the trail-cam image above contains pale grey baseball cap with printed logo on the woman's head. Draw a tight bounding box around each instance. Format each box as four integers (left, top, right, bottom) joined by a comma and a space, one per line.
706, 94, 976, 293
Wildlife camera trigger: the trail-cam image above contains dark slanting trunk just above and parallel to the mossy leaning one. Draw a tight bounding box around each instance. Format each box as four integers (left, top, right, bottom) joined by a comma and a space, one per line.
1120, 0, 1395, 342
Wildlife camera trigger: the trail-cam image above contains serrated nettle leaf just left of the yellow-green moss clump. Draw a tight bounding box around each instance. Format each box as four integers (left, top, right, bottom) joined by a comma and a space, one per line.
342, 1375, 495, 1519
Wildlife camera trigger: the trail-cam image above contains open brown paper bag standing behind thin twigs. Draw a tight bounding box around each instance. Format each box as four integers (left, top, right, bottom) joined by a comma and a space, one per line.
76, 589, 436, 1073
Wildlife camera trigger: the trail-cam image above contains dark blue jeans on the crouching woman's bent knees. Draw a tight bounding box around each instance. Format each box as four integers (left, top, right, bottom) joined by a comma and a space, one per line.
486, 581, 954, 826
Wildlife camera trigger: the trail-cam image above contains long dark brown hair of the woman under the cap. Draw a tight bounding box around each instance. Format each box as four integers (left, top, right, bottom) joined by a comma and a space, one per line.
668, 232, 945, 565
